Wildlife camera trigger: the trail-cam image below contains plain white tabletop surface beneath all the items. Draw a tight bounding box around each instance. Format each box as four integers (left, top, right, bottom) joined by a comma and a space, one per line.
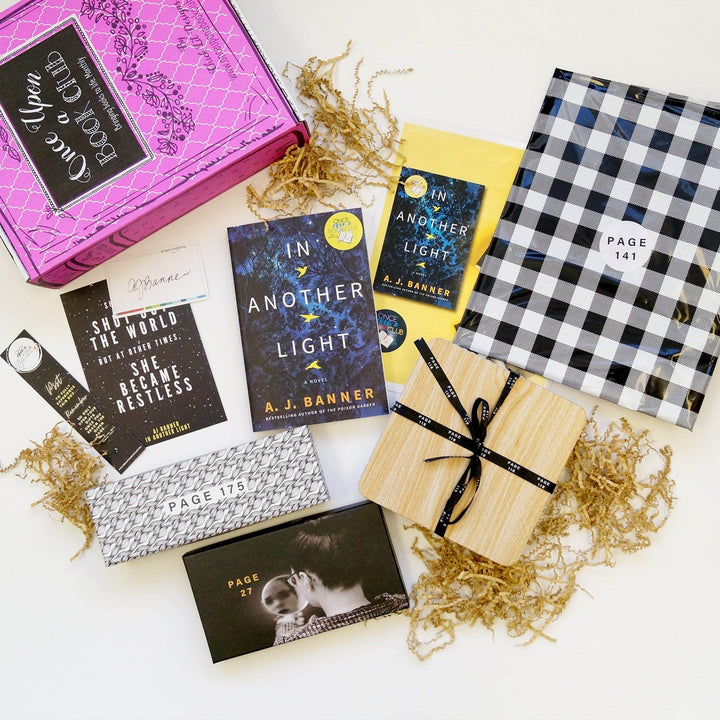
0, 0, 720, 720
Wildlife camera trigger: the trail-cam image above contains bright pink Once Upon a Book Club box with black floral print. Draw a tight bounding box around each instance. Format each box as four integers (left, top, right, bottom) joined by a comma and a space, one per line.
0, 0, 308, 287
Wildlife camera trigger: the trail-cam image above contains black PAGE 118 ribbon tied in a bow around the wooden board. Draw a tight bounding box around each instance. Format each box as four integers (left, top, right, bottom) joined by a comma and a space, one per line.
393, 338, 555, 537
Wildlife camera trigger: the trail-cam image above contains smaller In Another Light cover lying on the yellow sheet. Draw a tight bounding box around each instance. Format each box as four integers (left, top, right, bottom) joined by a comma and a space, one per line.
374, 166, 484, 310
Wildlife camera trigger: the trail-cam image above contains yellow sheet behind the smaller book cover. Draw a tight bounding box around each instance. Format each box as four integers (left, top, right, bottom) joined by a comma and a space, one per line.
370, 123, 523, 385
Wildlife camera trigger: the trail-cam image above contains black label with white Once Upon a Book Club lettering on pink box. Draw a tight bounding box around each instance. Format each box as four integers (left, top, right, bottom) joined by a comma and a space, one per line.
0, 19, 152, 211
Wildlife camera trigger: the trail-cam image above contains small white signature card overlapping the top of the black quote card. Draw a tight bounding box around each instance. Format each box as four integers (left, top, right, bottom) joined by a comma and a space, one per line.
107, 245, 209, 317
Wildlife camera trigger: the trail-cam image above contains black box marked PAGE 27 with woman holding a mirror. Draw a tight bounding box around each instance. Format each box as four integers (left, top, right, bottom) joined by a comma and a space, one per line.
183, 503, 408, 662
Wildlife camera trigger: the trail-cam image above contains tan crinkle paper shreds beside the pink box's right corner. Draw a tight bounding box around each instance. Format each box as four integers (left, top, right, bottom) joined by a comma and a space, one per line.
247, 42, 410, 220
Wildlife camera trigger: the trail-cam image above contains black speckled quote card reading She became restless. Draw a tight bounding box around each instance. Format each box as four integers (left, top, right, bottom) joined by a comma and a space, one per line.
60, 281, 226, 445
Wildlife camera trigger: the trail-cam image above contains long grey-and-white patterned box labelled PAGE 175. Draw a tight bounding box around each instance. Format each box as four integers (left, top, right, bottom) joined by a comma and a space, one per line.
86, 427, 329, 565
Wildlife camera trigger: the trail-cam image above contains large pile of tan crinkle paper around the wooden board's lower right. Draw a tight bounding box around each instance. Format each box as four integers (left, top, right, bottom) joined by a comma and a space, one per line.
408, 416, 675, 660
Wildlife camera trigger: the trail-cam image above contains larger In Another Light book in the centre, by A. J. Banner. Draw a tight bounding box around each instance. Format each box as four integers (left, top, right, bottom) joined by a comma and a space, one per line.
228, 209, 388, 431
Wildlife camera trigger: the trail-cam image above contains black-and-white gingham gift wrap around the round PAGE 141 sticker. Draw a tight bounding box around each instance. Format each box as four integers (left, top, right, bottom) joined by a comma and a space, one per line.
455, 70, 720, 428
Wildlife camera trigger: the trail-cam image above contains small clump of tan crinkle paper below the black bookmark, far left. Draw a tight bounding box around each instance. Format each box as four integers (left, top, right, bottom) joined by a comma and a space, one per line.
0, 425, 104, 560
